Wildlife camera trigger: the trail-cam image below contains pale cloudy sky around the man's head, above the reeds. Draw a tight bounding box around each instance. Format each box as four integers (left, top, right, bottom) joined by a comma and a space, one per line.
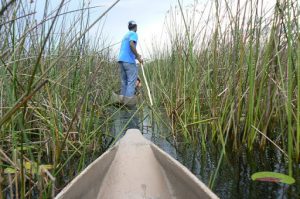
36, 0, 276, 58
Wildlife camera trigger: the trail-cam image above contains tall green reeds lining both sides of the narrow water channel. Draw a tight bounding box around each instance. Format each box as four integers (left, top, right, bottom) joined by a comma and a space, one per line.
0, 0, 300, 198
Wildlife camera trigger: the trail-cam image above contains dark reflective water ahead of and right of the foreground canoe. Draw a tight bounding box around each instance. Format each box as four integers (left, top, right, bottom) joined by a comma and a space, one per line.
112, 107, 300, 198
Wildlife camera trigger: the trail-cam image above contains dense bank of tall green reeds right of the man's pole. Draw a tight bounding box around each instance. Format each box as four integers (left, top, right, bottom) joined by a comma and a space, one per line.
147, 0, 300, 175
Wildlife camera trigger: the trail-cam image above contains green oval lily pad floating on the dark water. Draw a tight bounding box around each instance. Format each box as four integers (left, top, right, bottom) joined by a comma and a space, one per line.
251, 171, 295, 184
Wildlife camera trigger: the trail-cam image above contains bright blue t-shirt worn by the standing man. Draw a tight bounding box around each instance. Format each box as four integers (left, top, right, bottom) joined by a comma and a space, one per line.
119, 31, 138, 64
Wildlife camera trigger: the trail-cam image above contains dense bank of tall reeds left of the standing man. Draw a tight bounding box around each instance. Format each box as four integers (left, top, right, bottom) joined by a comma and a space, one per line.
0, 0, 119, 198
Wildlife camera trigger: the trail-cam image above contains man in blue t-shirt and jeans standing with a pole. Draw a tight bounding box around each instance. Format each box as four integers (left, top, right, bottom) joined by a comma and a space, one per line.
118, 21, 143, 98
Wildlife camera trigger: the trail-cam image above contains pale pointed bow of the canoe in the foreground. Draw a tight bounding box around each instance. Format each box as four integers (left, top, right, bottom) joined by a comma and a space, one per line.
56, 129, 218, 199
